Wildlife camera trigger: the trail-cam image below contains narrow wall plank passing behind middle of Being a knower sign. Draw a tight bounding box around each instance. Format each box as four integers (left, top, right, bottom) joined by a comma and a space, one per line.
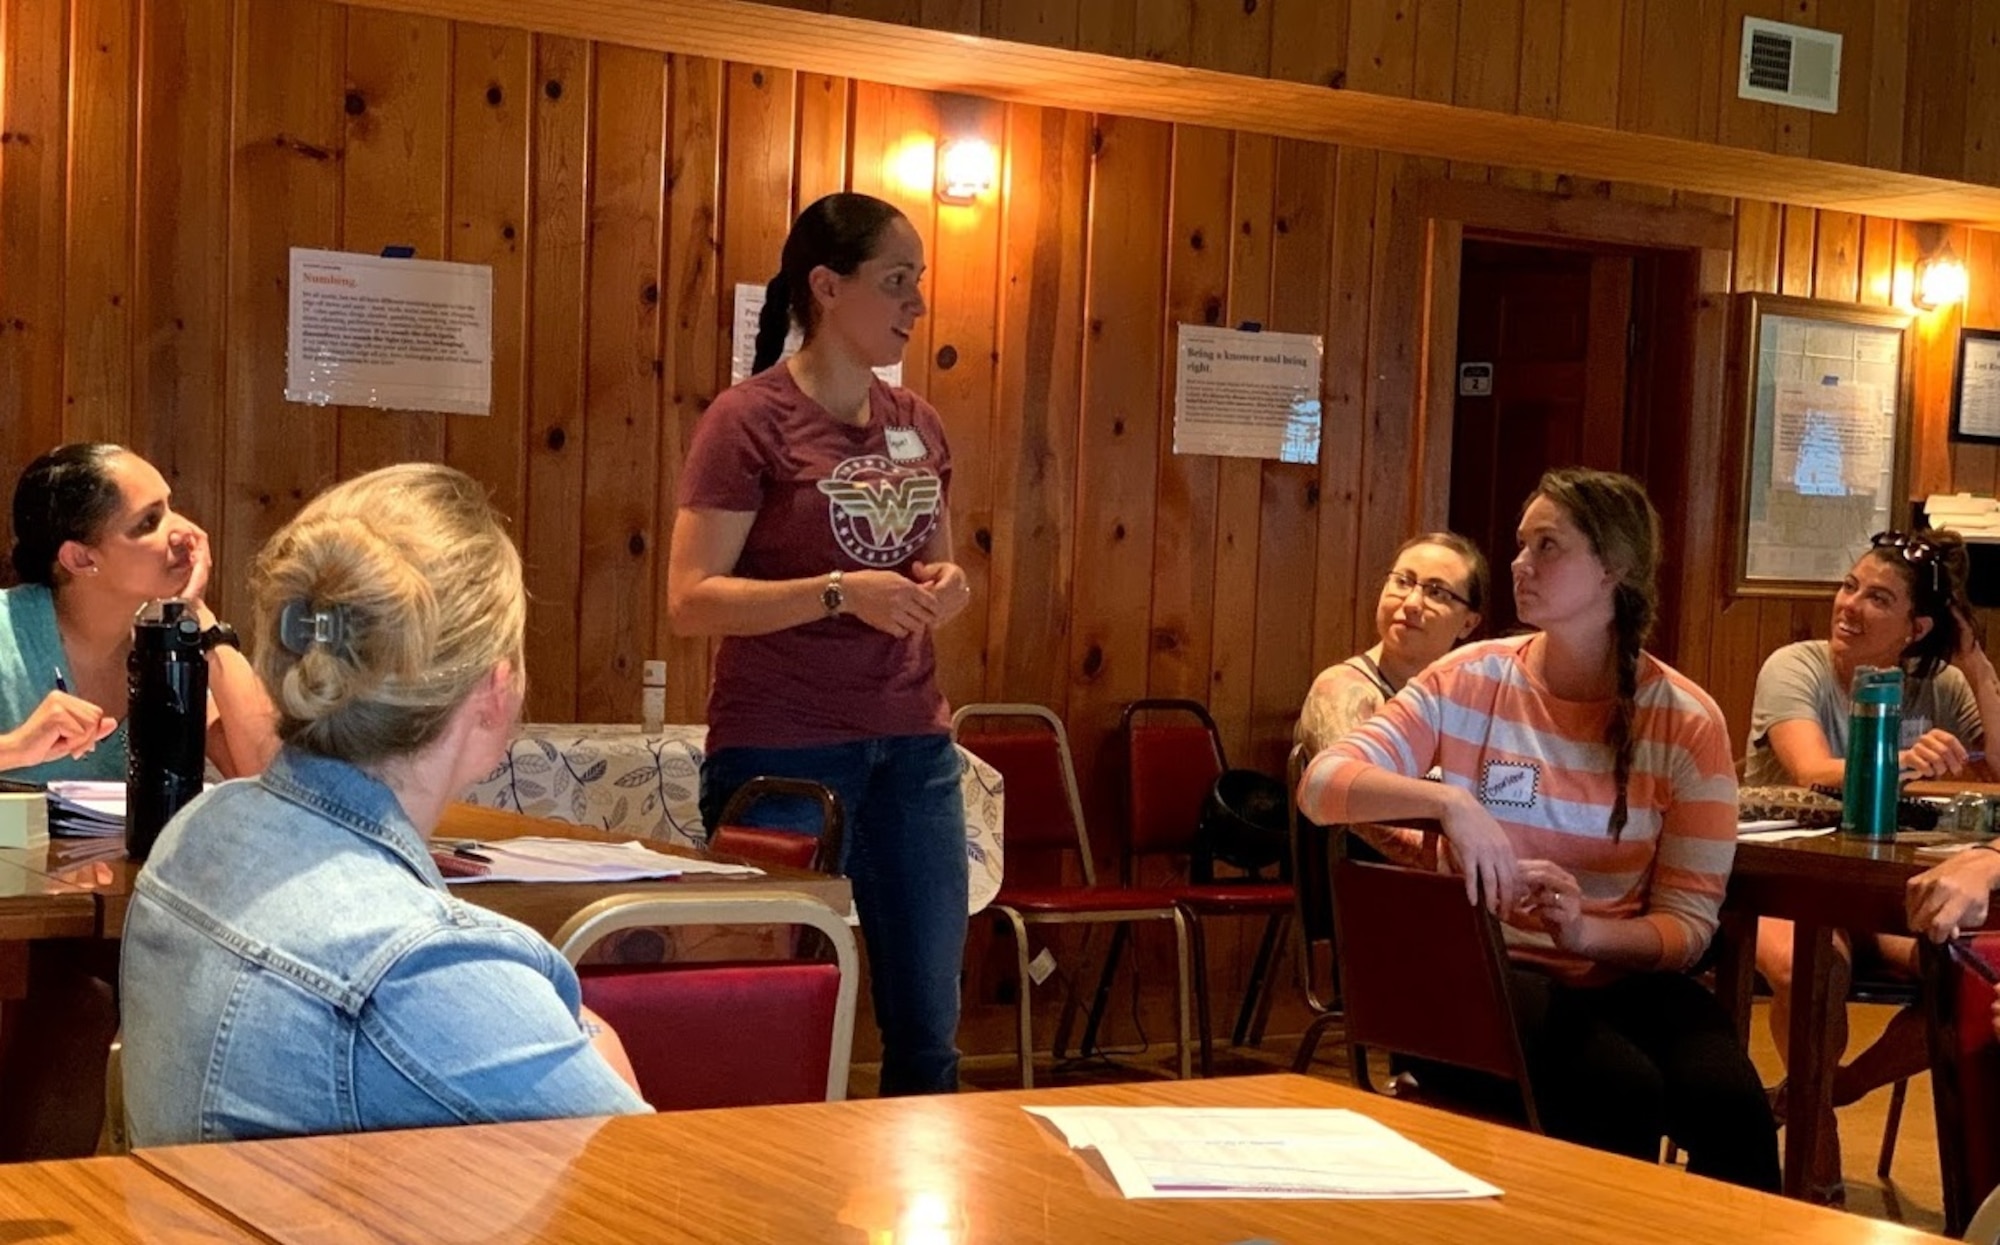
1208, 134, 1278, 772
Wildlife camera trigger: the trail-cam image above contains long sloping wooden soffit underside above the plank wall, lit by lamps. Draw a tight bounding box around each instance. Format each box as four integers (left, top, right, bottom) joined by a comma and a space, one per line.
342, 0, 2000, 228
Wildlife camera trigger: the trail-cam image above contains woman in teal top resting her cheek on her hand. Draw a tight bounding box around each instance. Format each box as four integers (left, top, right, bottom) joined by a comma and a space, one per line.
0, 444, 278, 783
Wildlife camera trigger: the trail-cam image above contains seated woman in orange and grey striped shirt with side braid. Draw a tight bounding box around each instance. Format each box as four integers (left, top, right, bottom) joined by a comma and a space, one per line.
1298, 470, 1778, 1191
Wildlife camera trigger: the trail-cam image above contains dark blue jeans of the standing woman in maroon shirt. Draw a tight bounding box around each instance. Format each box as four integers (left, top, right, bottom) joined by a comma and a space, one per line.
702, 735, 968, 1097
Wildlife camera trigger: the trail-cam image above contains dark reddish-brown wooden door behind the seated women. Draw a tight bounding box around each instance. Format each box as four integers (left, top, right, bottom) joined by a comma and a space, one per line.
1450, 238, 1632, 635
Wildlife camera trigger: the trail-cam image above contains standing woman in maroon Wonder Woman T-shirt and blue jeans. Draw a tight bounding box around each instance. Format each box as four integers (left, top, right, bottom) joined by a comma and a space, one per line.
666, 194, 972, 1095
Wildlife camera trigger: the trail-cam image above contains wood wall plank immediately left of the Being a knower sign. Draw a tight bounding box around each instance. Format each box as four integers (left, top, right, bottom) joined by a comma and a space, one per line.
1068, 116, 1172, 823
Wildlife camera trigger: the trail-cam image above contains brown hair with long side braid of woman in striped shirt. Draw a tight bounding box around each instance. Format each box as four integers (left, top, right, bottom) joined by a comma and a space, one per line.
1528, 466, 1660, 841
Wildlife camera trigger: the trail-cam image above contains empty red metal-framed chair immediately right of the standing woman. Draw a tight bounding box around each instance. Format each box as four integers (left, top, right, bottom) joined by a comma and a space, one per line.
952, 705, 1192, 1089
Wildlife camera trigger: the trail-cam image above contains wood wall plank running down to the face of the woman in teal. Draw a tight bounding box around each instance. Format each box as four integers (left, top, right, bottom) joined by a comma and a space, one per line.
133, 0, 232, 560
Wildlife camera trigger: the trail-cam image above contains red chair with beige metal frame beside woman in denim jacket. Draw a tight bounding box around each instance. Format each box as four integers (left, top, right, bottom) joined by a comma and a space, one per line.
554, 891, 860, 1111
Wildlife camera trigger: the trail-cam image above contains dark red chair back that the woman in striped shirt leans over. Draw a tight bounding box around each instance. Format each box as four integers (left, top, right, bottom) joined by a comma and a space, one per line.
1332, 835, 1542, 1133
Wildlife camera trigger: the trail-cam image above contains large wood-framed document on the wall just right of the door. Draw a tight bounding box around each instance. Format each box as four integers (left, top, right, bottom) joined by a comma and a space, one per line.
1734, 294, 1912, 596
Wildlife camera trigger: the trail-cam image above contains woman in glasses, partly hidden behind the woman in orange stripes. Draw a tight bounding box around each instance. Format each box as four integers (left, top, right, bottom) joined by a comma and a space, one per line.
1292, 532, 1492, 865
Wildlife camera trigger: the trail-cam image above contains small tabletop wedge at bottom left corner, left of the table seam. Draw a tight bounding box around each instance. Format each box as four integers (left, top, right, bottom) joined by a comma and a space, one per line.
0, 1159, 264, 1245
